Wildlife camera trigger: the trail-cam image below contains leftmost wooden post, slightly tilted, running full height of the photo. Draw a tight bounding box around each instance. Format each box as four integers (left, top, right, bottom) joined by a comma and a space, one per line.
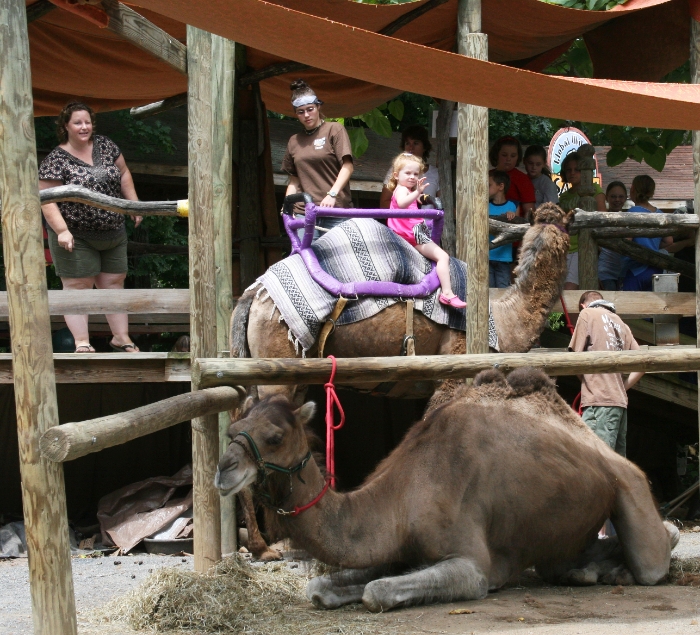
0, 0, 77, 635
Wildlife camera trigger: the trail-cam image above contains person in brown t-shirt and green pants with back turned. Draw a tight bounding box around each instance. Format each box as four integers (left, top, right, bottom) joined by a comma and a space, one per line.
569, 291, 644, 456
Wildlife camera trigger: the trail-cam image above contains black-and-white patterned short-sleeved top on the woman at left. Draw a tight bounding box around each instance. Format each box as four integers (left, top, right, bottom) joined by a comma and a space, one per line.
39, 135, 126, 240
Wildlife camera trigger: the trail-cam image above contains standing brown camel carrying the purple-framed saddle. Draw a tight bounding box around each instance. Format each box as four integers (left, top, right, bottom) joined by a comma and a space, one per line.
230, 203, 574, 560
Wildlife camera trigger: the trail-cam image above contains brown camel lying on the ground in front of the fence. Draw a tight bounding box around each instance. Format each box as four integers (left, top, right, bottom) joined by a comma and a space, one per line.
215, 368, 679, 611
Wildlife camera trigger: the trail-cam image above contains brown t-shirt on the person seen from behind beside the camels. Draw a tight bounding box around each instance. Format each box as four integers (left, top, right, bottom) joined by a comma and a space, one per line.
569, 307, 639, 408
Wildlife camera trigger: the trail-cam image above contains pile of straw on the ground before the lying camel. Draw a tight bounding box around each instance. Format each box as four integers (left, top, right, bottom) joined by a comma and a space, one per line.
92, 556, 398, 635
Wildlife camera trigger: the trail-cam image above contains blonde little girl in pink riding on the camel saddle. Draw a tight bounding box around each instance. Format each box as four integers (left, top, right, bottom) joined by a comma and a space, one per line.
387, 152, 467, 309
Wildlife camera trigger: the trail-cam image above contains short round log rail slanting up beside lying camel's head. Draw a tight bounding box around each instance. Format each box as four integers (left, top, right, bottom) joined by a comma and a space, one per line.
39, 386, 239, 463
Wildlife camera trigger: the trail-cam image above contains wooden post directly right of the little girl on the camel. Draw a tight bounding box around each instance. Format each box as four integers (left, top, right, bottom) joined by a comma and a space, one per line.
456, 0, 489, 353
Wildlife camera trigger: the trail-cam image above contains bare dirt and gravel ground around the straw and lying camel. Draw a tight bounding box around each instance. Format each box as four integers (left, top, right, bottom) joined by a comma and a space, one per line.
0, 531, 700, 635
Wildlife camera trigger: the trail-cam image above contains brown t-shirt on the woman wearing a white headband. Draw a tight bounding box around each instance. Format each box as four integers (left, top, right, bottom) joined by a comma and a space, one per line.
282, 121, 352, 208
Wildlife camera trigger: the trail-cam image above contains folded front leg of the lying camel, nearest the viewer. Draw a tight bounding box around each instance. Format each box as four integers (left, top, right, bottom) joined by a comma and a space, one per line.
362, 558, 489, 613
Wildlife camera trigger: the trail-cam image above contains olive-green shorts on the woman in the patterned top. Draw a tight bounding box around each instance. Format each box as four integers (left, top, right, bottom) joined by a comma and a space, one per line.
47, 227, 129, 278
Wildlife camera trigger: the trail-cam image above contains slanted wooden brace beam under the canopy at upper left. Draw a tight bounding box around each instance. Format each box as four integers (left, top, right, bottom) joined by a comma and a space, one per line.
102, 0, 187, 75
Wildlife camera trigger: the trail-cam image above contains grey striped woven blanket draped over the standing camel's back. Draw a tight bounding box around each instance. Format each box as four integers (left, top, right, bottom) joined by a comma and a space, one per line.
252, 219, 498, 355
